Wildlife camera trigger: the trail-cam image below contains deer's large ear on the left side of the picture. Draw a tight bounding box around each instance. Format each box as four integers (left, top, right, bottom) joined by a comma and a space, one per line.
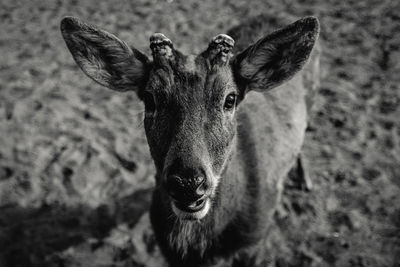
60, 17, 150, 92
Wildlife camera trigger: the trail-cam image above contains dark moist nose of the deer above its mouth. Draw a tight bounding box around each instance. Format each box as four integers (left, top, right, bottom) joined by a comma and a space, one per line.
166, 174, 207, 203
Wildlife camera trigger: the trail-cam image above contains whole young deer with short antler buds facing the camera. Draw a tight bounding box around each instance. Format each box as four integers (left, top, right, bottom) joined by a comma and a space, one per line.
60, 13, 320, 267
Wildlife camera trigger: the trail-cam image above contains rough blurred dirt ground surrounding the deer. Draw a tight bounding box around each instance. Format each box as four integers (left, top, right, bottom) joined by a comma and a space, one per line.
0, 0, 400, 267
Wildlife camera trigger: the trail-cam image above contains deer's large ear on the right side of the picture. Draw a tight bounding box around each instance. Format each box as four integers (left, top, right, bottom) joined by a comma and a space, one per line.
232, 17, 319, 92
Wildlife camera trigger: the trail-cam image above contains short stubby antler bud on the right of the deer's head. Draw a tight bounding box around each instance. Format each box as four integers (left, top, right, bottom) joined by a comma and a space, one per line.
205, 34, 235, 66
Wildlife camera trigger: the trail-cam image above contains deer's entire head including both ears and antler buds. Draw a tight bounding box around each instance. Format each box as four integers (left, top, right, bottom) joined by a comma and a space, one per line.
61, 17, 319, 219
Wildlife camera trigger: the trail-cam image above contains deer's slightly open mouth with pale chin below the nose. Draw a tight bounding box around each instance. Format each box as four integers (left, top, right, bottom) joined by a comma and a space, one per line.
171, 198, 210, 220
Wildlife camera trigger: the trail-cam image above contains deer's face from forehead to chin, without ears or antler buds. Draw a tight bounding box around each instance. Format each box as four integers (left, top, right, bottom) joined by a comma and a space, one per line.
143, 51, 239, 221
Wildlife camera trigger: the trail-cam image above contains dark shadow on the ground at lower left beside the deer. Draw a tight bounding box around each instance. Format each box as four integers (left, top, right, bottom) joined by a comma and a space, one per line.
0, 190, 151, 267
